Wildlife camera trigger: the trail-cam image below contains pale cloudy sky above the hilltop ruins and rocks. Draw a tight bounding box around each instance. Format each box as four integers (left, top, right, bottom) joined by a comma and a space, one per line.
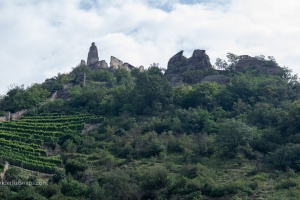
0, 0, 300, 94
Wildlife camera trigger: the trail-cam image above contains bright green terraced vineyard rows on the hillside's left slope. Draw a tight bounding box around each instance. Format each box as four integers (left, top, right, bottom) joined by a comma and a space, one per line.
0, 115, 102, 173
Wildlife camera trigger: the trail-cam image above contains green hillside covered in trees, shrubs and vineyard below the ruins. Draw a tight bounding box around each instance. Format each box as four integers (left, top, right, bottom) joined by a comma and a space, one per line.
0, 54, 300, 200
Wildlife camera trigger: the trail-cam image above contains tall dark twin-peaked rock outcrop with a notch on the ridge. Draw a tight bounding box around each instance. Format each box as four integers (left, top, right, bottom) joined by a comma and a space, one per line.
165, 49, 214, 85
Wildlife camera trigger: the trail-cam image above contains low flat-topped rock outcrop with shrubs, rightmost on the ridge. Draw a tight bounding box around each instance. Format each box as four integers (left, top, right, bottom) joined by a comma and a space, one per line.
235, 55, 282, 76
